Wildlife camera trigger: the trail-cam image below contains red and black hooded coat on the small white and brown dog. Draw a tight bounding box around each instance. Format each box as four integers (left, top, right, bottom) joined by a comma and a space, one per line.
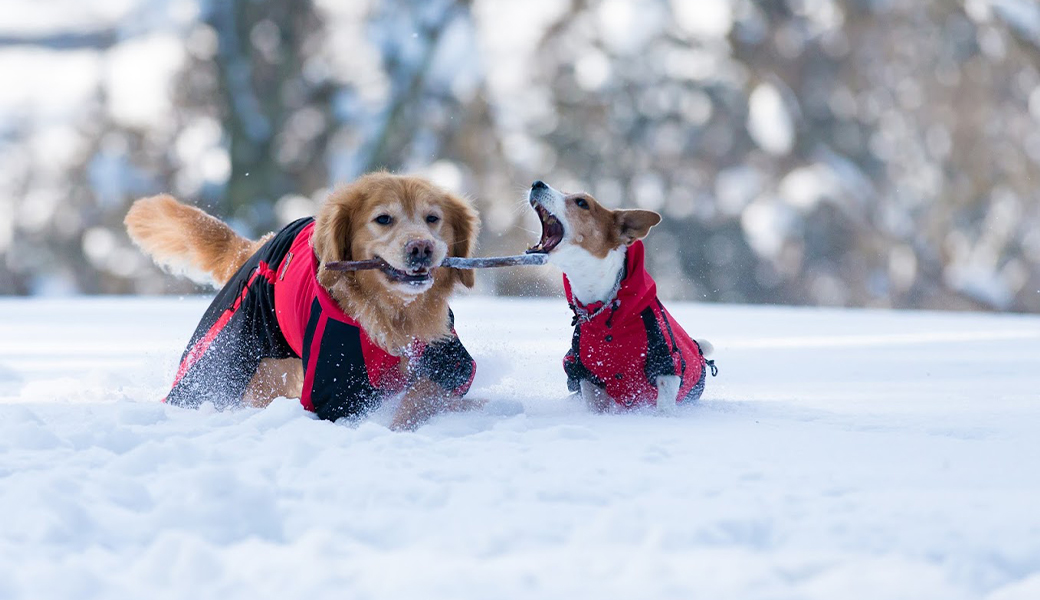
564, 241, 714, 407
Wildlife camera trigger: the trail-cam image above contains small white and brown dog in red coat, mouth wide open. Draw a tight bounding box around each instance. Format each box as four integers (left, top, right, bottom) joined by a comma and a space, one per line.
527, 181, 716, 411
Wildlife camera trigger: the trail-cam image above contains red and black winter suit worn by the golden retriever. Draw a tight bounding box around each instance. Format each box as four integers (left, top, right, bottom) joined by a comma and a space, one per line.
166, 218, 476, 420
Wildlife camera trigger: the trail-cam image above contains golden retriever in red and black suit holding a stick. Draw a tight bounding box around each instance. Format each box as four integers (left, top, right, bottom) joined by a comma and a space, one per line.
125, 173, 479, 428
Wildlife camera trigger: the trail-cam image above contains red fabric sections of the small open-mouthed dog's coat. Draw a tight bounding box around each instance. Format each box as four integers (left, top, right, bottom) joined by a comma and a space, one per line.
564, 241, 704, 407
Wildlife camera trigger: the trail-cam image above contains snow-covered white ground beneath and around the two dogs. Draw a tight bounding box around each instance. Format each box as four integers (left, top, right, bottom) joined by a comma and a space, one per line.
0, 297, 1040, 600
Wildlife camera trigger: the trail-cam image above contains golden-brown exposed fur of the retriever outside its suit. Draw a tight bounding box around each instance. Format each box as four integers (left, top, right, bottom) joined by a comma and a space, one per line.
124, 173, 480, 428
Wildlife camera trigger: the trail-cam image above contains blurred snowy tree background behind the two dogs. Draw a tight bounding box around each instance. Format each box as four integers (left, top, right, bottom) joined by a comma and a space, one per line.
0, 0, 1040, 312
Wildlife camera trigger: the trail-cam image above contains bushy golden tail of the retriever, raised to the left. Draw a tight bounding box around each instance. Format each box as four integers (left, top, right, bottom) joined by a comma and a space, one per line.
123, 194, 266, 286
